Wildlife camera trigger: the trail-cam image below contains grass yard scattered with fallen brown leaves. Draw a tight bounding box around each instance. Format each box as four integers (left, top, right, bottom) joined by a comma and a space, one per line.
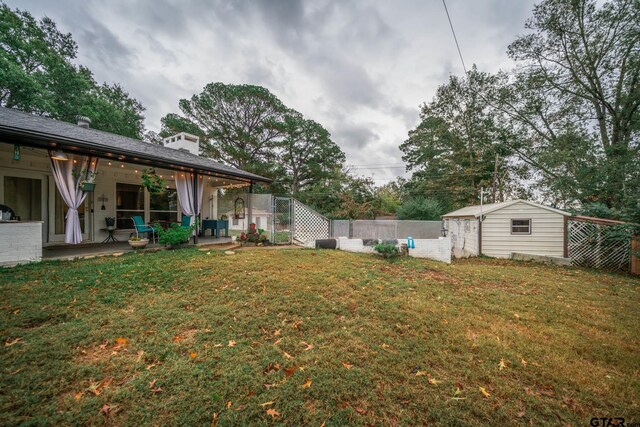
0, 249, 640, 426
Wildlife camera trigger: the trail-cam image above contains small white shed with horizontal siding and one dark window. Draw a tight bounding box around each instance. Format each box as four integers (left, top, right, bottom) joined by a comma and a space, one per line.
442, 200, 570, 258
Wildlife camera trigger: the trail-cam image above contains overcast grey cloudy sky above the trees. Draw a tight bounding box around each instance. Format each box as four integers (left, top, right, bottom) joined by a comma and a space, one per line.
11, 0, 534, 185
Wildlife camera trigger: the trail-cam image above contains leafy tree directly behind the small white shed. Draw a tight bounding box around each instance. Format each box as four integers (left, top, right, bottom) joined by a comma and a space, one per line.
400, 66, 526, 208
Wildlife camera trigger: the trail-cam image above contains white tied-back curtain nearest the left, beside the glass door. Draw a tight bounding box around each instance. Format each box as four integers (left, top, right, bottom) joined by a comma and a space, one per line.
49, 153, 98, 245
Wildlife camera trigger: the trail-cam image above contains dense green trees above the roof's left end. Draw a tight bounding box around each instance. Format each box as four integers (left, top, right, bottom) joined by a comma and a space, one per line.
0, 3, 144, 138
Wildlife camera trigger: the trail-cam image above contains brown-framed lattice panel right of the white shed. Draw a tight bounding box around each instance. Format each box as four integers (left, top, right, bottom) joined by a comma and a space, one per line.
568, 221, 631, 271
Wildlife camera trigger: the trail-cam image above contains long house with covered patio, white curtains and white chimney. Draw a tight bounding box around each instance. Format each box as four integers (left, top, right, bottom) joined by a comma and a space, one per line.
0, 108, 270, 265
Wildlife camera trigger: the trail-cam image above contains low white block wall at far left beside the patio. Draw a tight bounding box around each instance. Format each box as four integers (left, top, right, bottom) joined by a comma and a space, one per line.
0, 221, 42, 266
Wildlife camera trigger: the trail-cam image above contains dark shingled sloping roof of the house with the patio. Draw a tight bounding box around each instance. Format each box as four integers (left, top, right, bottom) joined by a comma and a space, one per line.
0, 107, 271, 183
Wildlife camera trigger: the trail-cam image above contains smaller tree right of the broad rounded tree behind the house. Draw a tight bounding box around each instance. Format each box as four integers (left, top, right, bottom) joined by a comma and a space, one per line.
277, 111, 345, 196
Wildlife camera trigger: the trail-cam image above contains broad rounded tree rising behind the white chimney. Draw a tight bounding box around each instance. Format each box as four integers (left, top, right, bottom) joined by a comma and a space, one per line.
162, 83, 287, 172
